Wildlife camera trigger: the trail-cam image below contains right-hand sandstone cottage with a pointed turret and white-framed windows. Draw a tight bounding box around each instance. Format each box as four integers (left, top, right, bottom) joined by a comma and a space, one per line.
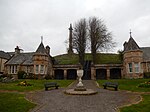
123, 34, 150, 78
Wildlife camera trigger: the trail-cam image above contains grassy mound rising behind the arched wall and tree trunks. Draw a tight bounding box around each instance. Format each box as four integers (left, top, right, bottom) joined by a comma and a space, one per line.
54, 53, 122, 65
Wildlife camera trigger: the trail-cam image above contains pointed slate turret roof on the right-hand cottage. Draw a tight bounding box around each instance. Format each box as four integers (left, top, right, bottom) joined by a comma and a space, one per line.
124, 37, 140, 51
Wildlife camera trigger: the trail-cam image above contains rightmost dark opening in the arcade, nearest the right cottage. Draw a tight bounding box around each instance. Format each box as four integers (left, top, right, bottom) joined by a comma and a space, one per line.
110, 68, 121, 79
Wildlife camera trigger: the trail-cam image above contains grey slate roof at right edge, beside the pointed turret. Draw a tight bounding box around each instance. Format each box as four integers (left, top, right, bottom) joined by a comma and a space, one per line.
140, 47, 150, 61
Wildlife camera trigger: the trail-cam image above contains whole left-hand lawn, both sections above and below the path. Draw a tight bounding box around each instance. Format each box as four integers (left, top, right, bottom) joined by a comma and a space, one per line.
0, 80, 74, 112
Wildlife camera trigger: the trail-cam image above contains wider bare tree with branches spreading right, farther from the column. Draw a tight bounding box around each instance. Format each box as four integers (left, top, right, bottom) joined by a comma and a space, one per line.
88, 17, 115, 63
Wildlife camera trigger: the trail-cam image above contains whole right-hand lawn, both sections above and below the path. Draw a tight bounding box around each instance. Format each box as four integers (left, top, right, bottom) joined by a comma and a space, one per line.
97, 79, 150, 112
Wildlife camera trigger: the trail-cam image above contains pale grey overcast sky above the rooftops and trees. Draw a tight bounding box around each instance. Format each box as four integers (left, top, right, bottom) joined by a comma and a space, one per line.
0, 0, 150, 56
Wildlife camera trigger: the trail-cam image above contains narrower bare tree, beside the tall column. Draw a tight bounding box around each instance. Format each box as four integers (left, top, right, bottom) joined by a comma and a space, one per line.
72, 19, 87, 66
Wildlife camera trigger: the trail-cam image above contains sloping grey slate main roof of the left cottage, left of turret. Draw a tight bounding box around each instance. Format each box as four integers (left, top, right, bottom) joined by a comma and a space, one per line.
6, 52, 34, 65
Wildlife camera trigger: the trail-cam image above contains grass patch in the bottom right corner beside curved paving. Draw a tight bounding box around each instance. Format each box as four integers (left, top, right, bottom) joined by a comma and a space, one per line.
120, 95, 150, 112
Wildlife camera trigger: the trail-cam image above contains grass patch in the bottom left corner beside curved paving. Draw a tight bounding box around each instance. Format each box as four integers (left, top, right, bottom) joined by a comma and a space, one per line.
0, 93, 36, 112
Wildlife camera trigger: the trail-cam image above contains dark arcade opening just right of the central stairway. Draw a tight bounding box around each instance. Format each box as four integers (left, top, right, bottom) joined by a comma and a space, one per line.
96, 69, 107, 79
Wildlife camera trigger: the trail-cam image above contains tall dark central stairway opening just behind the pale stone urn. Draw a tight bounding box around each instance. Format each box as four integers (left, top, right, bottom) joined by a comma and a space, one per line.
82, 60, 91, 80
